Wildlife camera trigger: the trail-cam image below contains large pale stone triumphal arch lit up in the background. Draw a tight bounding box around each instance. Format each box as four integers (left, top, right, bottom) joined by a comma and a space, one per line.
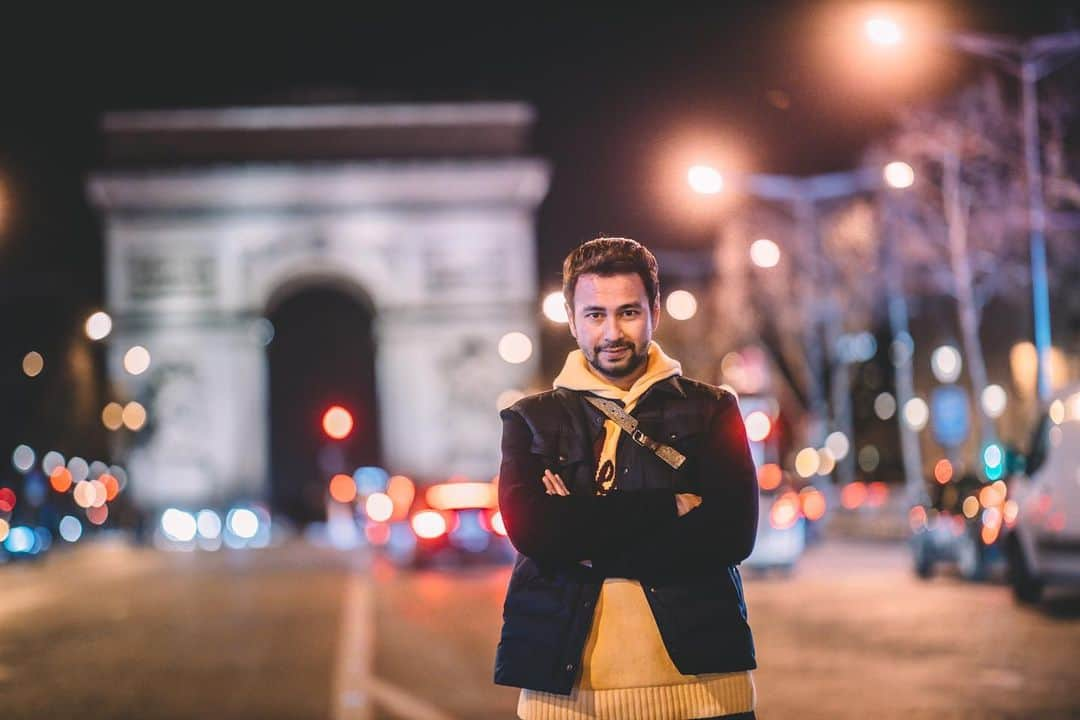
89, 103, 549, 511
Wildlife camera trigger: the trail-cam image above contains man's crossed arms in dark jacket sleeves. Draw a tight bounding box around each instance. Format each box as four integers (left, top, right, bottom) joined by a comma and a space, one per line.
499, 395, 757, 579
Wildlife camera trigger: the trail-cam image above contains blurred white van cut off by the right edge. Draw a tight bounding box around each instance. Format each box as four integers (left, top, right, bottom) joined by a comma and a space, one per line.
1005, 384, 1080, 602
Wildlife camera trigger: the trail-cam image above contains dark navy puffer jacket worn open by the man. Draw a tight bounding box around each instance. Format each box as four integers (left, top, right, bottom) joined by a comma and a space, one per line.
495, 378, 757, 695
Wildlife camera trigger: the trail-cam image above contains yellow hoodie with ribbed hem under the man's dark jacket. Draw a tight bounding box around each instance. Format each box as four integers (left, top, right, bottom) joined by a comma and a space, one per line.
517, 342, 756, 720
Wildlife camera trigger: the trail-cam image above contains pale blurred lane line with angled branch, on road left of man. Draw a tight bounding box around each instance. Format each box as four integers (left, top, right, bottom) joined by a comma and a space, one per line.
332, 569, 455, 720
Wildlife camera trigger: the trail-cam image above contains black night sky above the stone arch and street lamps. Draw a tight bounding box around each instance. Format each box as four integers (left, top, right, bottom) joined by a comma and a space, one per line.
0, 2, 1080, 479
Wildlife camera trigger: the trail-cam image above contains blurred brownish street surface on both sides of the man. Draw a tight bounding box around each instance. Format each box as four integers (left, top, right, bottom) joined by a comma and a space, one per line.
0, 540, 1080, 720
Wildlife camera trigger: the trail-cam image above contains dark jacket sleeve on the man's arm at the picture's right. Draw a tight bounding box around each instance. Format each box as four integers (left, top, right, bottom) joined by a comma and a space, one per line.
594, 394, 758, 580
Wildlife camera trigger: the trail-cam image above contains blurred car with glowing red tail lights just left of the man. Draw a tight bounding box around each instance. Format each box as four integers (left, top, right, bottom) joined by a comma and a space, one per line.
362, 476, 514, 568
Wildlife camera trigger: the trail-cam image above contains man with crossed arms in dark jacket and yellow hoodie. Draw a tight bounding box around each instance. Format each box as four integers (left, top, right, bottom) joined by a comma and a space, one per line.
495, 237, 757, 720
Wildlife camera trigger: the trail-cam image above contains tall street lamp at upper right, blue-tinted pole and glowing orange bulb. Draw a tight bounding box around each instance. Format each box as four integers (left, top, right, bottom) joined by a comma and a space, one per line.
864, 16, 1080, 403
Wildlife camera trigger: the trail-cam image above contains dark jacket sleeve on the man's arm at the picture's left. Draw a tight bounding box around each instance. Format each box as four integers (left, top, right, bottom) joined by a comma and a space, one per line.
499, 410, 677, 563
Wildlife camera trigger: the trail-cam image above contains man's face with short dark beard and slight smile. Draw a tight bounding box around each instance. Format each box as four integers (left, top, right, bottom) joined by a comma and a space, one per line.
567, 273, 660, 384
